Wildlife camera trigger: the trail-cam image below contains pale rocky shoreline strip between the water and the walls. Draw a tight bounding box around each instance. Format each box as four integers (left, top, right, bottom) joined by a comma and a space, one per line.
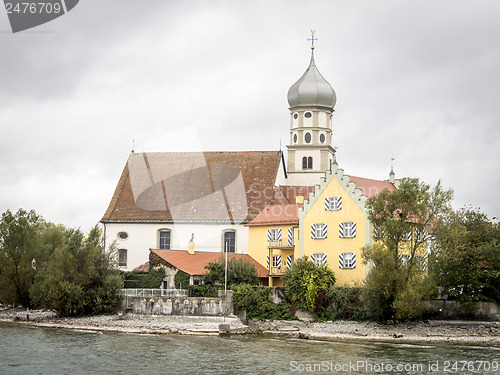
0, 309, 500, 345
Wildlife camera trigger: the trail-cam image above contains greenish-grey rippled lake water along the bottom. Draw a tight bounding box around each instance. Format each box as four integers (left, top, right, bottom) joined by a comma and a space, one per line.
0, 324, 500, 375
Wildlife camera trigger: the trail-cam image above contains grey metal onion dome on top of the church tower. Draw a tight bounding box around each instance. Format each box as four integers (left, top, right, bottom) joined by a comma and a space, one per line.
288, 52, 337, 110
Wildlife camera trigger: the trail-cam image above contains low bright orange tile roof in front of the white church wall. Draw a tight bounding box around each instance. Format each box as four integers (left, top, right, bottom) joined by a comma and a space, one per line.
150, 249, 269, 277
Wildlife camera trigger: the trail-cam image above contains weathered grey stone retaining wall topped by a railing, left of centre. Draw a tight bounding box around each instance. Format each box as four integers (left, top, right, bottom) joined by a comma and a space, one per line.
123, 290, 234, 316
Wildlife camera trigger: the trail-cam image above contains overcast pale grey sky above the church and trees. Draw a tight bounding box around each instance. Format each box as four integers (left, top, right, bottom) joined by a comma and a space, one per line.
0, 0, 500, 231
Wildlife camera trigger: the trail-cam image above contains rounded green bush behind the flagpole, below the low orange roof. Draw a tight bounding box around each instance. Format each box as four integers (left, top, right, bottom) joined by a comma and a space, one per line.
203, 255, 259, 285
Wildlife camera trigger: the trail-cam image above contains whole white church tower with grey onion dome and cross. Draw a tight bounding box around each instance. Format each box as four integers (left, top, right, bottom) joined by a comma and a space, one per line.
287, 31, 337, 185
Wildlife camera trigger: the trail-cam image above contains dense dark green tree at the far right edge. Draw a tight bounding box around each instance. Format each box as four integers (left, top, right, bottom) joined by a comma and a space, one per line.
434, 208, 500, 311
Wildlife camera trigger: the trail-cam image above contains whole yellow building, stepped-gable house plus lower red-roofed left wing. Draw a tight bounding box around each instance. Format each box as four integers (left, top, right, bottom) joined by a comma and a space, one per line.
248, 163, 396, 286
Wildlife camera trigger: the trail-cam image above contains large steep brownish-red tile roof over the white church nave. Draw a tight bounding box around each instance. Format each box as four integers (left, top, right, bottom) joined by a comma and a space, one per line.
102, 151, 281, 223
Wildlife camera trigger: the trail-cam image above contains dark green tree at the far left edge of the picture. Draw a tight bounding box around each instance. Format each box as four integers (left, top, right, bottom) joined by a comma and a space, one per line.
0, 209, 44, 307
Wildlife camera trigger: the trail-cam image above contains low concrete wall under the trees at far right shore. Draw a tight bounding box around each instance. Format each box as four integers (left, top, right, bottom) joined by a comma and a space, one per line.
423, 299, 500, 321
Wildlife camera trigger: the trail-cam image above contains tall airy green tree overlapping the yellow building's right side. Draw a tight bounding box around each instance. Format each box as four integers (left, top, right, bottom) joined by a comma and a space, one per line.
363, 178, 453, 320
